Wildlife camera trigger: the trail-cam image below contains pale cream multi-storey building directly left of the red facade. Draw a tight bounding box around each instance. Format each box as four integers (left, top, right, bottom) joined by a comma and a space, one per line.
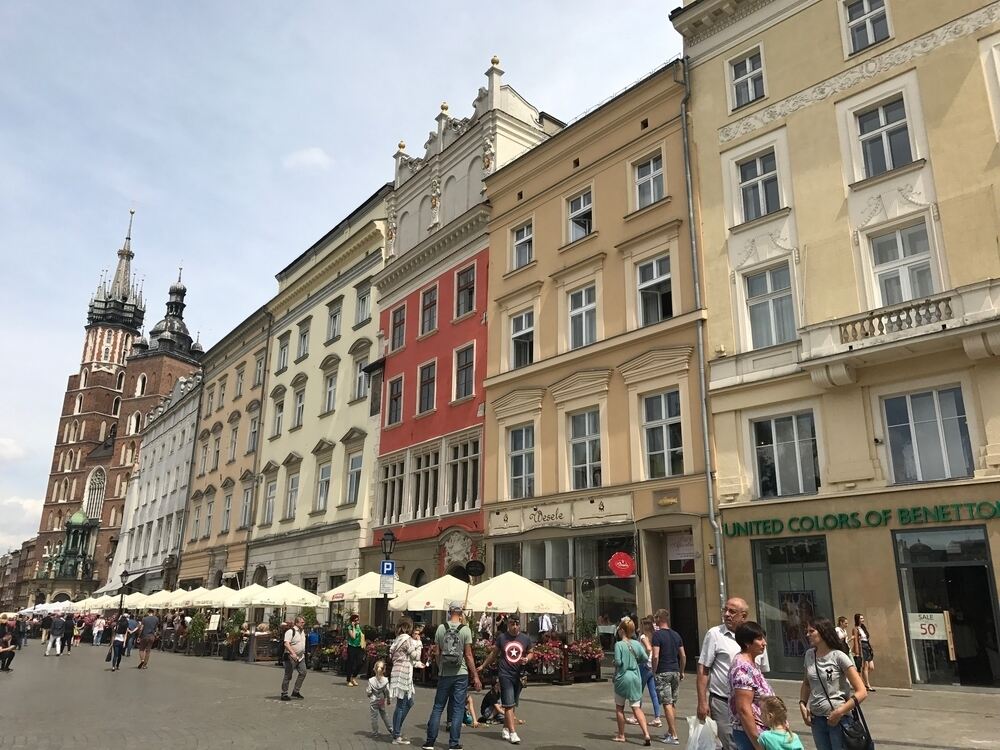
247, 185, 390, 604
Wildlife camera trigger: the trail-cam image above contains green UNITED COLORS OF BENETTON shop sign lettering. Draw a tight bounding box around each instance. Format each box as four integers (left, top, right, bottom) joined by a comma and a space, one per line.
722, 500, 1000, 538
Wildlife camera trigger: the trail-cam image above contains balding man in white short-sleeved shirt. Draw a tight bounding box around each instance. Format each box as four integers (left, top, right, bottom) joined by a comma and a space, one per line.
697, 596, 771, 750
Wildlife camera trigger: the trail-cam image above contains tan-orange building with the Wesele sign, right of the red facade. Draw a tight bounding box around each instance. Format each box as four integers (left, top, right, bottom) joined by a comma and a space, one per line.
483, 63, 718, 651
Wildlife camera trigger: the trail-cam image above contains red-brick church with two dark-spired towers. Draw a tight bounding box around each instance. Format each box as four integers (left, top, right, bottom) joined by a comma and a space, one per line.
33, 212, 202, 603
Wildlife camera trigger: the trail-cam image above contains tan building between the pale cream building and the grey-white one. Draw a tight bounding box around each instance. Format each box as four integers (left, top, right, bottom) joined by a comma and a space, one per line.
178, 307, 271, 589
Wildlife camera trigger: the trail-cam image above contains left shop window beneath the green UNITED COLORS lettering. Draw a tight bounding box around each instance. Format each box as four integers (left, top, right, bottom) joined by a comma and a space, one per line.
753, 536, 834, 677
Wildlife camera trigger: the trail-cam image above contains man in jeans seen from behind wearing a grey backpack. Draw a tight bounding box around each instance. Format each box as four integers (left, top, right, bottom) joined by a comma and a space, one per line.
423, 601, 483, 750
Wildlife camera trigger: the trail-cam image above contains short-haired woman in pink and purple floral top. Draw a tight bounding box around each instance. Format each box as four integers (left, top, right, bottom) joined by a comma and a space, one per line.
729, 620, 774, 750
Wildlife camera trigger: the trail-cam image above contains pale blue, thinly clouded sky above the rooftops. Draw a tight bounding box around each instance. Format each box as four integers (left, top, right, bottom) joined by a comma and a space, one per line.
0, 0, 681, 553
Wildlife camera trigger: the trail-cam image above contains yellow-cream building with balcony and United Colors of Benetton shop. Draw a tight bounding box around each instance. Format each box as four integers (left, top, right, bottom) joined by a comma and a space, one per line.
671, 0, 1000, 687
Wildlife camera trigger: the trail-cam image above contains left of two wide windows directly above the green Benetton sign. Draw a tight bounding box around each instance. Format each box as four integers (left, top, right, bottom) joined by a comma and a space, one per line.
753, 412, 820, 497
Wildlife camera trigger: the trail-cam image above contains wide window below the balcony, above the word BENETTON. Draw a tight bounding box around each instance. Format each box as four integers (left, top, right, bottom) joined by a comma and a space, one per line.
883, 387, 973, 483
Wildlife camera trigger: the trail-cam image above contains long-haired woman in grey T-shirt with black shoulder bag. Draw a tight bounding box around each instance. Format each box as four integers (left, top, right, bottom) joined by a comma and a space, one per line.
799, 618, 871, 750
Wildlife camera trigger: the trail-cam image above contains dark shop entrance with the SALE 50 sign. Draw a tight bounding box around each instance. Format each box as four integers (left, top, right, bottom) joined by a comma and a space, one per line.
895, 527, 1000, 686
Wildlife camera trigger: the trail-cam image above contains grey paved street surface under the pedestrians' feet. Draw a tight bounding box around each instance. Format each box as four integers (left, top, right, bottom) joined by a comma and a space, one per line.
0, 641, 1000, 750
